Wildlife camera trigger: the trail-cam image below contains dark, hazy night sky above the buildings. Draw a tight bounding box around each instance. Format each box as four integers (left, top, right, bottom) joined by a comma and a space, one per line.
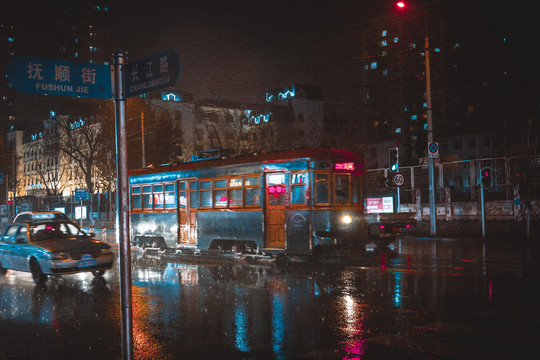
3, 0, 538, 106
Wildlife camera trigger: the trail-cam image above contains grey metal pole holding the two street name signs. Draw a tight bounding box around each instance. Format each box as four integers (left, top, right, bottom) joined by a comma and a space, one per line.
113, 49, 133, 360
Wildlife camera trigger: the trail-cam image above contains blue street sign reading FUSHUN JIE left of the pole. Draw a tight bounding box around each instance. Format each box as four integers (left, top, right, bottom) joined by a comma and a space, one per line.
7, 56, 112, 99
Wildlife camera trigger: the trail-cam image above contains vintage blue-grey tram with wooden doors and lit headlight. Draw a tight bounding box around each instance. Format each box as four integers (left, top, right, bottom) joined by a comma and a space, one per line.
128, 148, 364, 255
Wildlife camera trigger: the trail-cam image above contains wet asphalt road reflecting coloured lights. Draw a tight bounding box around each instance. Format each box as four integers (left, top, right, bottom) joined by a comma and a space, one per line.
0, 238, 540, 360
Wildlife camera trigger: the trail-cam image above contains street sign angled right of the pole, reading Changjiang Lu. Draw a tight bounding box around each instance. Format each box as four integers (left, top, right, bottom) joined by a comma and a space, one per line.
124, 49, 180, 98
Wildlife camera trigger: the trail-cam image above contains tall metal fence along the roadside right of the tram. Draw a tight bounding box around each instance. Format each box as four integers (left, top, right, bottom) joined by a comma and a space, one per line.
366, 156, 540, 203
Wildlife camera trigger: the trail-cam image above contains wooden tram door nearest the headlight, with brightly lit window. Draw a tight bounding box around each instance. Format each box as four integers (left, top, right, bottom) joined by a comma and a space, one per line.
265, 172, 289, 249
